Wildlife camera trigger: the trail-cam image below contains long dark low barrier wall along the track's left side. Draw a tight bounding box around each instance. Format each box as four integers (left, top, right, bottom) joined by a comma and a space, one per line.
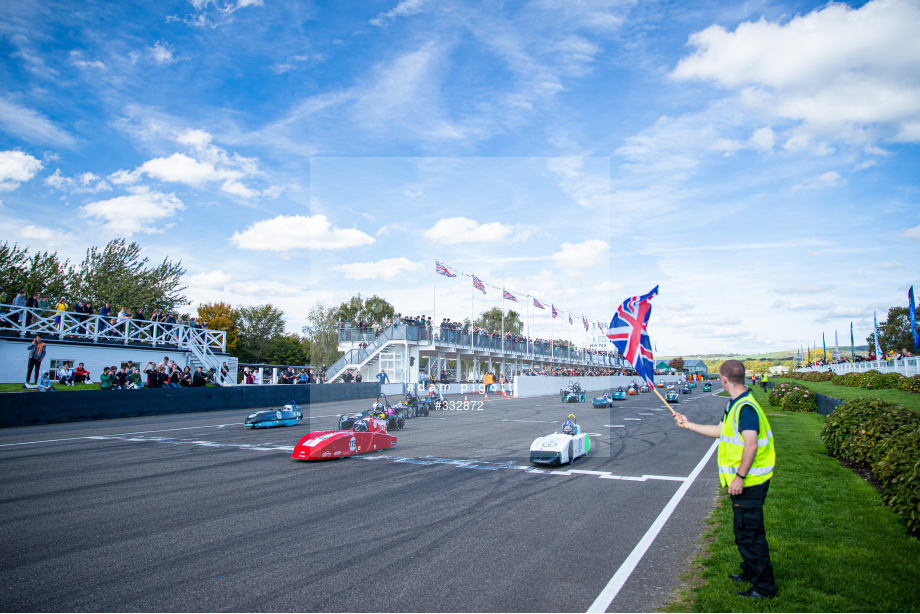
0, 382, 380, 428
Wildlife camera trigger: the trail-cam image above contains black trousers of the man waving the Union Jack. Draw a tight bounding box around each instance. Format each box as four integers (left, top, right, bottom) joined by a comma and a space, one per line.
731, 480, 776, 595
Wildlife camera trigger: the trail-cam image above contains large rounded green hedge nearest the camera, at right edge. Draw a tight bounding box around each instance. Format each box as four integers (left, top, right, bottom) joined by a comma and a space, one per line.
821, 399, 920, 536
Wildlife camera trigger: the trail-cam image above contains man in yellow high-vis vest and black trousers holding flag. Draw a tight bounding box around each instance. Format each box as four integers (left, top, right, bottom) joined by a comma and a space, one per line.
674, 360, 776, 599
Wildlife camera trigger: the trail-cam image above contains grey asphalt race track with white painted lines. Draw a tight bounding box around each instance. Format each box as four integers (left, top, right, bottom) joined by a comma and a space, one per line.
0, 388, 726, 612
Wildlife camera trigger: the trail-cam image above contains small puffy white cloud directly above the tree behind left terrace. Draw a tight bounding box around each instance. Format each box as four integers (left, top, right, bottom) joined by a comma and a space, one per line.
80, 186, 185, 236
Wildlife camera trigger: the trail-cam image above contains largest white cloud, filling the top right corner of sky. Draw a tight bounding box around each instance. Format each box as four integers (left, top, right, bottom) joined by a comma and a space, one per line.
672, 0, 920, 142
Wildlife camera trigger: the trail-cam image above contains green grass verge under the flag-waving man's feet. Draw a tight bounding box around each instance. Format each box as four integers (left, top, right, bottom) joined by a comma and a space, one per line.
663, 406, 920, 612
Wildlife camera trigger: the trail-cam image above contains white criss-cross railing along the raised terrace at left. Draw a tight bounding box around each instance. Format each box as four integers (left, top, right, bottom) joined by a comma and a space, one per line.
0, 305, 227, 354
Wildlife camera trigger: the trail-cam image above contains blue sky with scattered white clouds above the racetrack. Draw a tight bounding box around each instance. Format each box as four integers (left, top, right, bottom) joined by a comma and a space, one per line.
0, 0, 920, 356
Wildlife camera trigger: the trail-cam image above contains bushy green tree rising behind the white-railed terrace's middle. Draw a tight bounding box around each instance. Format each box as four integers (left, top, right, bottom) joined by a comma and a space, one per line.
70, 239, 189, 314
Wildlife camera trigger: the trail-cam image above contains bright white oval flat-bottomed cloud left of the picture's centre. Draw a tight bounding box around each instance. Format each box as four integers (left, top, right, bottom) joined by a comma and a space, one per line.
230, 214, 375, 252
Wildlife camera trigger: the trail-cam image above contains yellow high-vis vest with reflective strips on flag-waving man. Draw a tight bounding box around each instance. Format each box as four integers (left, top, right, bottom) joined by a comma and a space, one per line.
716, 394, 776, 486
